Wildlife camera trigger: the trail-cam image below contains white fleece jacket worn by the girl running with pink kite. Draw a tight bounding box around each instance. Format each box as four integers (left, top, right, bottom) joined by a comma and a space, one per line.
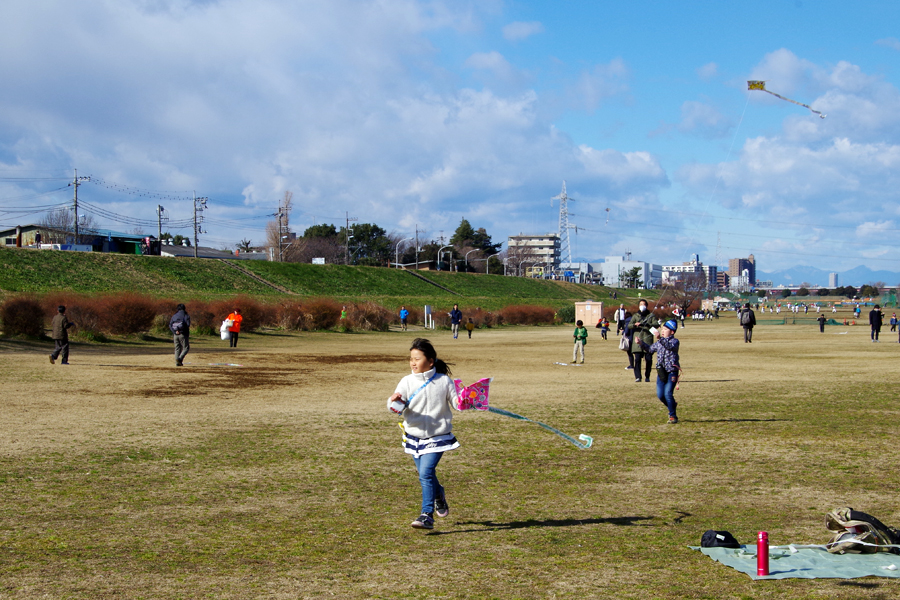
388, 369, 459, 439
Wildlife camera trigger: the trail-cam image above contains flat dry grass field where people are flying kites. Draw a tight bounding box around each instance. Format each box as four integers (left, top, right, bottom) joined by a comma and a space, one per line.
0, 316, 900, 599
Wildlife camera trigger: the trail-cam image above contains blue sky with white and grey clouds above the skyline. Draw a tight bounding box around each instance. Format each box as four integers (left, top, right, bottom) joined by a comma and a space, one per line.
0, 0, 900, 271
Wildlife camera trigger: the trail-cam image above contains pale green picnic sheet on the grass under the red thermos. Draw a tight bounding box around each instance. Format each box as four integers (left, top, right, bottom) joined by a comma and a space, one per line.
691, 544, 900, 579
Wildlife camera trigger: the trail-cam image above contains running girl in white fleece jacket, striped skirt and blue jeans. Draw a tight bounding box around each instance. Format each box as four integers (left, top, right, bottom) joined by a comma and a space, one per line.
388, 338, 459, 529
